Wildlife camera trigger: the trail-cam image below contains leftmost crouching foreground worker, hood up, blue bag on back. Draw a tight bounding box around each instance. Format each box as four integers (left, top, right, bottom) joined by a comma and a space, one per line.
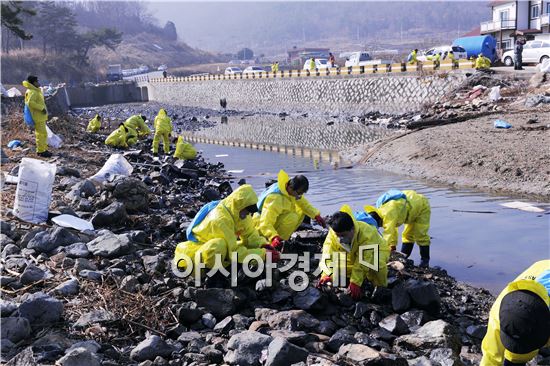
174, 184, 279, 284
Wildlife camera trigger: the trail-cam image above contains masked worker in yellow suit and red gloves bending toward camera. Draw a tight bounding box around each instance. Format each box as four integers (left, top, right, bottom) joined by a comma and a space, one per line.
319, 205, 390, 300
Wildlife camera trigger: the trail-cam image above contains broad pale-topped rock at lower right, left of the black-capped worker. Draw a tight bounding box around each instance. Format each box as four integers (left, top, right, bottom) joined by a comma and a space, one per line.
394, 320, 461, 354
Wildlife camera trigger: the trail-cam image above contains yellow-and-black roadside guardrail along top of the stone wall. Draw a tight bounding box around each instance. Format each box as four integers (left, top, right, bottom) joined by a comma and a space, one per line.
148, 60, 475, 83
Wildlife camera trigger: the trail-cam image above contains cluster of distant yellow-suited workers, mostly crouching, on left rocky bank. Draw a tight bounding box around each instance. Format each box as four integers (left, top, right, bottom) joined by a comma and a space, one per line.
86, 108, 197, 160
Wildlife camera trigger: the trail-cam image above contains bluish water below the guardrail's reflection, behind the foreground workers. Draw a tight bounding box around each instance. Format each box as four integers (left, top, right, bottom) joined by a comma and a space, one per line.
197, 144, 550, 294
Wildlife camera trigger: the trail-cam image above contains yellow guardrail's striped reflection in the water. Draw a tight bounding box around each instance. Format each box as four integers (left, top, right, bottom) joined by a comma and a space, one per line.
181, 133, 342, 164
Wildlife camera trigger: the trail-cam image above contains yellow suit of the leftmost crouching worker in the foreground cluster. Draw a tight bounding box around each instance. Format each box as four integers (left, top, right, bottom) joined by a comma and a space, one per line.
174, 184, 266, 268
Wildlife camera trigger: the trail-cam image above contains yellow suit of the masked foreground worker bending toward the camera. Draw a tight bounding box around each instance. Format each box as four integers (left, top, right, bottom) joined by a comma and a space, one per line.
321, 205, 390, 287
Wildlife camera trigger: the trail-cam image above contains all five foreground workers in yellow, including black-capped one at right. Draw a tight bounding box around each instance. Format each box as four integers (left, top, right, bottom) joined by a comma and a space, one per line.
174, 170, 550, 366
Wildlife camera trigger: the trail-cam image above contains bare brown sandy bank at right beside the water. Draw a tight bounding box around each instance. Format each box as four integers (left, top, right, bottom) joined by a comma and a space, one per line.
351, 105, 550, 201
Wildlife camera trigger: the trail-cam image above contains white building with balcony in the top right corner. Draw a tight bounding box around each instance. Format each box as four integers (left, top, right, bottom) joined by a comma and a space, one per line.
481, 0, 550, 50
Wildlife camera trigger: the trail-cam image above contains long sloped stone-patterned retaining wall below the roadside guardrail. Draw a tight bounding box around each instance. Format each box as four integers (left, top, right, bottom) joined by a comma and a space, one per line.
147, 71, 466, 114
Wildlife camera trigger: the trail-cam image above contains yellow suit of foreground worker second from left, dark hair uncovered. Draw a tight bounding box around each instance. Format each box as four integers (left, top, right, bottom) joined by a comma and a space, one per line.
254, 170, 320, 241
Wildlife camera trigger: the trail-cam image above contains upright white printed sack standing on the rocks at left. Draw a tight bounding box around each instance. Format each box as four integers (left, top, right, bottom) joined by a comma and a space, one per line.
13, 158, 57, 224
